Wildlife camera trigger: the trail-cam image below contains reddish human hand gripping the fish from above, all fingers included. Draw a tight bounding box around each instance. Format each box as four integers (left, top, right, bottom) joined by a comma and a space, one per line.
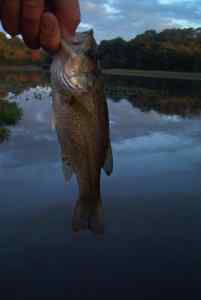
0, 0, 80, 52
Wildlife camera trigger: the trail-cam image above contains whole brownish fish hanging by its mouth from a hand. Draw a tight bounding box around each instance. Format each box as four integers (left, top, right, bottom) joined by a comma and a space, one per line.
51, 30, 113, 236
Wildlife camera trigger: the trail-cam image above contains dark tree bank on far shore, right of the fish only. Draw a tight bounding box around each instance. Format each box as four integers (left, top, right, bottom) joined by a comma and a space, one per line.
99, 28, 201, 72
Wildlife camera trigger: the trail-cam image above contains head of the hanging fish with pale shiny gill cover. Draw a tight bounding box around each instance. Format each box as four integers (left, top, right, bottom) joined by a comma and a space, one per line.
51, 31, 98, 94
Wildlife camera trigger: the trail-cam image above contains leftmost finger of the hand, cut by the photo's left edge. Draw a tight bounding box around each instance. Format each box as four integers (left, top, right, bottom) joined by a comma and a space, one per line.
1, 0, 20, 35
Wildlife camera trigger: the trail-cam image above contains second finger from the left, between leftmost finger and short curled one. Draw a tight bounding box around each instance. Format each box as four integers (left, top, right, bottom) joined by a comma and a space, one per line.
21, 0, 45, 49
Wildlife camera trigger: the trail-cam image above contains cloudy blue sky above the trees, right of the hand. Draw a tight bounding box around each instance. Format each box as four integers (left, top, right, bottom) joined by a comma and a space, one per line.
77, 0, 201, 41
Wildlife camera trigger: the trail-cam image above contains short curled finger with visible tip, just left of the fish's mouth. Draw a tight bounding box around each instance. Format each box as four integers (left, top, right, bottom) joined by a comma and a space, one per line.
40, 13, 61, 52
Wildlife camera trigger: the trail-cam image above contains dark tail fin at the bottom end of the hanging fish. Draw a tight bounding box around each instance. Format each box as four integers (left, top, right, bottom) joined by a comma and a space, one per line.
72, 200, 104, 238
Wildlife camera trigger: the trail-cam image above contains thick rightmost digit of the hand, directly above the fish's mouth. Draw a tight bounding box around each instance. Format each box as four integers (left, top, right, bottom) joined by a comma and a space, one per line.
54, 0, 81, 35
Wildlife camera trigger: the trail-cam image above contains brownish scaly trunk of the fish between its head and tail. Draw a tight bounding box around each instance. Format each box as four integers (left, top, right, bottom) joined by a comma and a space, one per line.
53, 80, 109, 194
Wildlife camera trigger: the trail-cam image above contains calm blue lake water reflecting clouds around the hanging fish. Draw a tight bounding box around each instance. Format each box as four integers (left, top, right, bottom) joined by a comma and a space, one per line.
0, 74, 201, 299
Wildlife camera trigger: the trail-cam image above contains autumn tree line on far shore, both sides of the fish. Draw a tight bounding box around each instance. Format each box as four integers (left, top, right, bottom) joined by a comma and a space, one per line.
0, 28, 201, 72
